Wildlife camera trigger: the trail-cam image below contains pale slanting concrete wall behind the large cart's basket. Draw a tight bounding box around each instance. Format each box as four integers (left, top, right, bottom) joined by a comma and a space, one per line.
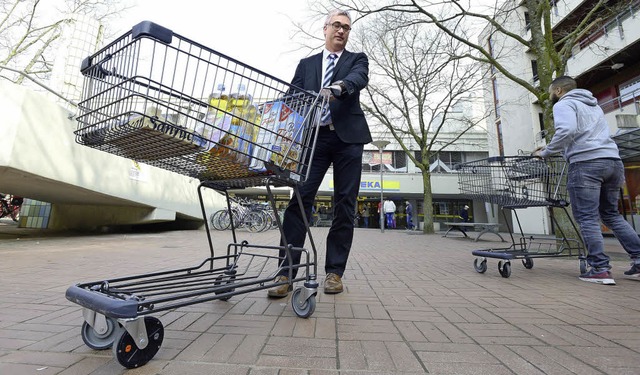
0, 81, 225, 229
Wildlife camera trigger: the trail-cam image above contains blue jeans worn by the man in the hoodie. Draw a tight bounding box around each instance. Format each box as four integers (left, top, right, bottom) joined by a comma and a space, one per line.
567, 159, 640, 270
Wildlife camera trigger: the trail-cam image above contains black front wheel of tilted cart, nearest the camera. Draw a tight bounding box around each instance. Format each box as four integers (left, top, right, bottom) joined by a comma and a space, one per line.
112, 316, 164, 368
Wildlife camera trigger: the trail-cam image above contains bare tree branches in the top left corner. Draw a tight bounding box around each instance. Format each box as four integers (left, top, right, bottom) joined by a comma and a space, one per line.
0, 0, 128, 84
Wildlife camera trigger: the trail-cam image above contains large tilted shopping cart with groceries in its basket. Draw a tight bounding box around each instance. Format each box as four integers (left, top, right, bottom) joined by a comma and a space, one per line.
66, 22, 326, 368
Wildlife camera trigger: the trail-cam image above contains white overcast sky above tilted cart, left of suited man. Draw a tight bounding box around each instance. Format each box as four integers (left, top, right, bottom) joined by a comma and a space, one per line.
111, 0, 322, 82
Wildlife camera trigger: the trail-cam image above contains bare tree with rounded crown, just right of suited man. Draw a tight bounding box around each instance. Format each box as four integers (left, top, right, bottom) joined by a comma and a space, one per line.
354, 14, 486, 233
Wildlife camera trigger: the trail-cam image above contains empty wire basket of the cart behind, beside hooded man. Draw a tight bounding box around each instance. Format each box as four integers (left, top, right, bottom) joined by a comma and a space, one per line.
455, 156, 569, 208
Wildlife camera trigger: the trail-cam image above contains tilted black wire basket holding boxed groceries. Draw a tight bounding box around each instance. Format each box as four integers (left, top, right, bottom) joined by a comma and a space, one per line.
75, 22, 325, 185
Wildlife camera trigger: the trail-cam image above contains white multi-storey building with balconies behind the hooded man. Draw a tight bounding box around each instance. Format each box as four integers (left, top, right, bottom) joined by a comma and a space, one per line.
480, 0, 640, 233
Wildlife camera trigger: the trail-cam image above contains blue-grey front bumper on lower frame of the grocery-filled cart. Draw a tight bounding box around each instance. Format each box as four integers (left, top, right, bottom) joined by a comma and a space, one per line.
65, 285, 138, 319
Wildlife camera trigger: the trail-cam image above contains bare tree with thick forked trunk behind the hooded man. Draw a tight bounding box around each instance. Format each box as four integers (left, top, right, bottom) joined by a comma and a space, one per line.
333, 0, 625, 140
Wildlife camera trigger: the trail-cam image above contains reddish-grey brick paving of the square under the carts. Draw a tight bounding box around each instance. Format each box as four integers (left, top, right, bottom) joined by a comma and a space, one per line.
0, 223, 640, 375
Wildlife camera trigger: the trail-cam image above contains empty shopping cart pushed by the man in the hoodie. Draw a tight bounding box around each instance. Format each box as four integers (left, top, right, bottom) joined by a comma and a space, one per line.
456, 156, 587, 278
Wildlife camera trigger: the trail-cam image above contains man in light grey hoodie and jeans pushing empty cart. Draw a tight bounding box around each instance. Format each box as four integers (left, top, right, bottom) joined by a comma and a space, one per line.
534, 76, 640, 285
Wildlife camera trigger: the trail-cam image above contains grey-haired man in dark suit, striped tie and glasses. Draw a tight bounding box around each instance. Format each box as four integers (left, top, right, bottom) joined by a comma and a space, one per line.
268, 10, 371, 298
